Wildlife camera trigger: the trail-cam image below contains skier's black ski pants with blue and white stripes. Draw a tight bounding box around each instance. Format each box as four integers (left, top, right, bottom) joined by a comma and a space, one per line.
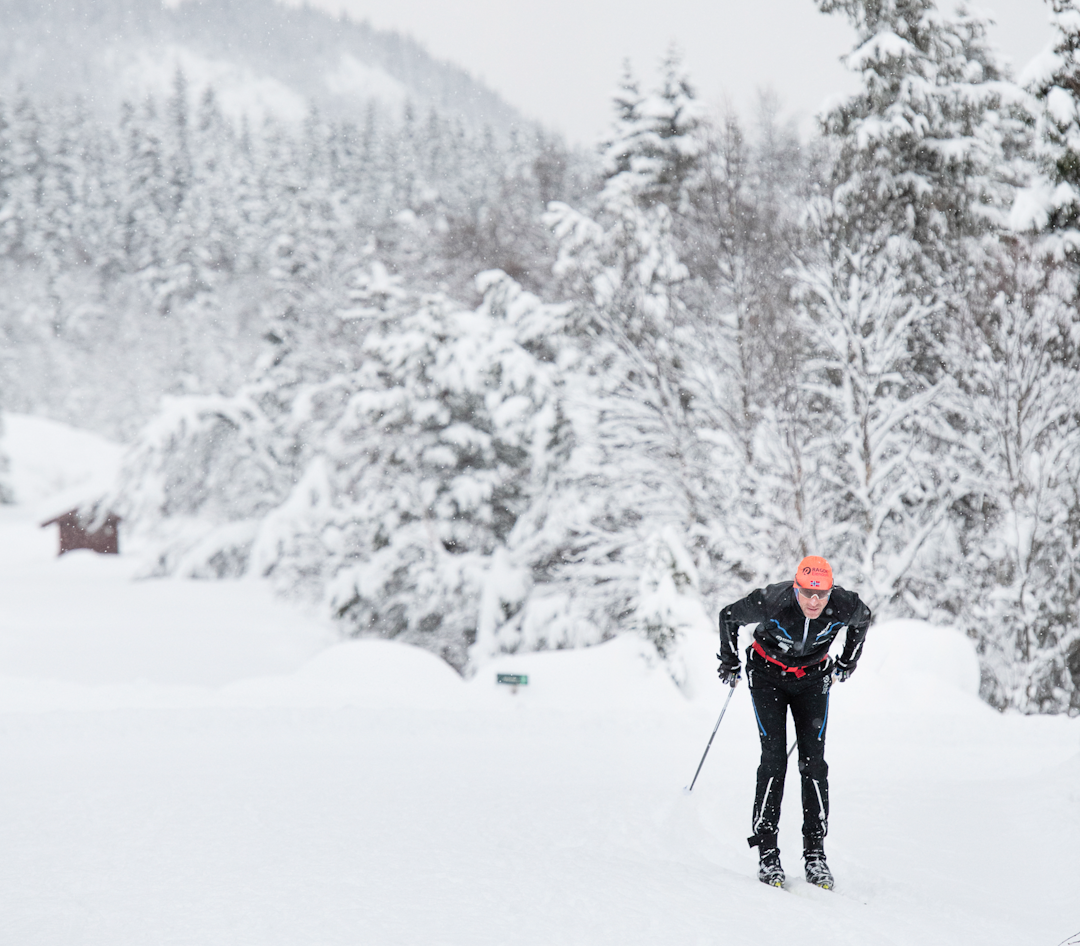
746, 657, 832, 850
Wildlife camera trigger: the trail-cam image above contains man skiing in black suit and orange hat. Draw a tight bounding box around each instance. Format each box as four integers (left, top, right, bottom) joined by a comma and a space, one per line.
716, 555, 870, 889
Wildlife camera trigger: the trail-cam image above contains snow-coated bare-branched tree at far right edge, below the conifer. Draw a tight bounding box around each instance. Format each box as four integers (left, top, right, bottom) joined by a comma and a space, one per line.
939, 242, 1080, 713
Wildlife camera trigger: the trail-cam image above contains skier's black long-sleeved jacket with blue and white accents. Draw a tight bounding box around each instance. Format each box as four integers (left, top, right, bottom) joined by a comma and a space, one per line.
718, 581, 870, 668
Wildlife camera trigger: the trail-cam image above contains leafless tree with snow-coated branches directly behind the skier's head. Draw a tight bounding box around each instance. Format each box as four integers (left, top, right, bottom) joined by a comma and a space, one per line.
798, 208, 953, 609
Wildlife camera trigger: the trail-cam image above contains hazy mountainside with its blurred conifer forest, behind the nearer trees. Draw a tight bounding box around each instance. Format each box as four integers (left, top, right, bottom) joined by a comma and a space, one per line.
0, 0, 589, 437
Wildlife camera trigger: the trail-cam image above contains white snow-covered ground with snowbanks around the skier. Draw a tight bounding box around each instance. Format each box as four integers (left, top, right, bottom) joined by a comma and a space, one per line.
0, 418, 1080, 946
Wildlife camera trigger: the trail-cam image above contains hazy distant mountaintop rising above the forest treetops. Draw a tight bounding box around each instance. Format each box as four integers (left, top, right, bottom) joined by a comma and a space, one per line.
0, 0, 527, 134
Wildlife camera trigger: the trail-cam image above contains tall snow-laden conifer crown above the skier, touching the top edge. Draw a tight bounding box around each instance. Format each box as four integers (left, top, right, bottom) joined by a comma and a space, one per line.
819, 0, 1023, 269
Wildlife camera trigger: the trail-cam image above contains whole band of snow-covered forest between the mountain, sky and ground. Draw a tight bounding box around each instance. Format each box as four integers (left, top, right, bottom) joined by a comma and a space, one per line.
0, 0, 1080, 713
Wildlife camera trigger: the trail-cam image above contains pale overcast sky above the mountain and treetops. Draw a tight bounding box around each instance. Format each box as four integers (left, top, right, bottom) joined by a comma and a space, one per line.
294, 0, 1051, 145
